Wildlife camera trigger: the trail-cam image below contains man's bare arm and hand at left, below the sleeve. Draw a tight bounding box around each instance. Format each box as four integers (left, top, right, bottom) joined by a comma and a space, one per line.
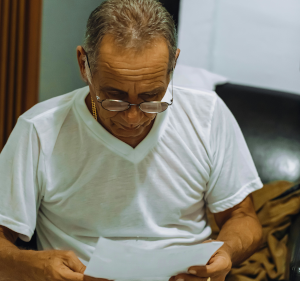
0, 225, 86, 281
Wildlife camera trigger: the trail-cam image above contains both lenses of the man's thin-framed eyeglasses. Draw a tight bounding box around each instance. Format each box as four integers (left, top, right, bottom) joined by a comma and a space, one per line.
102, 100, 168, 113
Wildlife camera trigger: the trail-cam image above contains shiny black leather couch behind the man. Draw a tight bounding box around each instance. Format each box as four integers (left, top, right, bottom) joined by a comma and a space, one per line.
17, 83, 300, 281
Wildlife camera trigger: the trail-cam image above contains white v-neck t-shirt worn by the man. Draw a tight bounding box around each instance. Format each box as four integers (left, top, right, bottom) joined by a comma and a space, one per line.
0, 84, 262, 264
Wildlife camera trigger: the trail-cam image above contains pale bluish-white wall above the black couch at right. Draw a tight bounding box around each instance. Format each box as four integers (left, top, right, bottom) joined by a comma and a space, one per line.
178, 0, 300, 94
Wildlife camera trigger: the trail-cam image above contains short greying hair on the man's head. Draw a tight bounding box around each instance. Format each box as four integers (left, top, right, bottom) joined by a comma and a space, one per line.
84, 0, 177, 76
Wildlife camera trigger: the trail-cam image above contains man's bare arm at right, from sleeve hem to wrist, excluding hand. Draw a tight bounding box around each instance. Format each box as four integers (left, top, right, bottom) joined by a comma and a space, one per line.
214, 195, 262, 265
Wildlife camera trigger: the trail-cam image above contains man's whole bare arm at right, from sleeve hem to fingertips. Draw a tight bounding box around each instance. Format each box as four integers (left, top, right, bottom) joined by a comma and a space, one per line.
170, 195, 262, 281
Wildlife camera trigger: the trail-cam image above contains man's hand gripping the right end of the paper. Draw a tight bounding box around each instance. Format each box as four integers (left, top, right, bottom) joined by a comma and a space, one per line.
169, 240, 232, 281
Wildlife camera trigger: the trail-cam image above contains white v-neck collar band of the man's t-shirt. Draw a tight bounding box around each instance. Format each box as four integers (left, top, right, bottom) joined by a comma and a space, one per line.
75, 86, 172, 163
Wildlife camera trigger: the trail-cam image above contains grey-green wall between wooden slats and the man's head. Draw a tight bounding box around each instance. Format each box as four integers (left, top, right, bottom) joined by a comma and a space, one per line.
39, 0, 103, 101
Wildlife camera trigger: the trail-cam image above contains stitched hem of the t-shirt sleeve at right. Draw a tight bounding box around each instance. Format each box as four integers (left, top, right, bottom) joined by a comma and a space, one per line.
208, 178, 263, 213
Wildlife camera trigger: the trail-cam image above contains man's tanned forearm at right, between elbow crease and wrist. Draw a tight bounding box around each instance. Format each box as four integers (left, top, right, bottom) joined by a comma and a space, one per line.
217, 214, 262, 265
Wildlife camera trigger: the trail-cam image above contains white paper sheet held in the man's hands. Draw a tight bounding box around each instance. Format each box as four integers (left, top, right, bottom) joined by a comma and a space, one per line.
84, 237, 223, 281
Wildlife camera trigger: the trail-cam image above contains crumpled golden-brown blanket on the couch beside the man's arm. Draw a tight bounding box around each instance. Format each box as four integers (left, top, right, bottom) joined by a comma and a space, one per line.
207, 181, 300, 281
